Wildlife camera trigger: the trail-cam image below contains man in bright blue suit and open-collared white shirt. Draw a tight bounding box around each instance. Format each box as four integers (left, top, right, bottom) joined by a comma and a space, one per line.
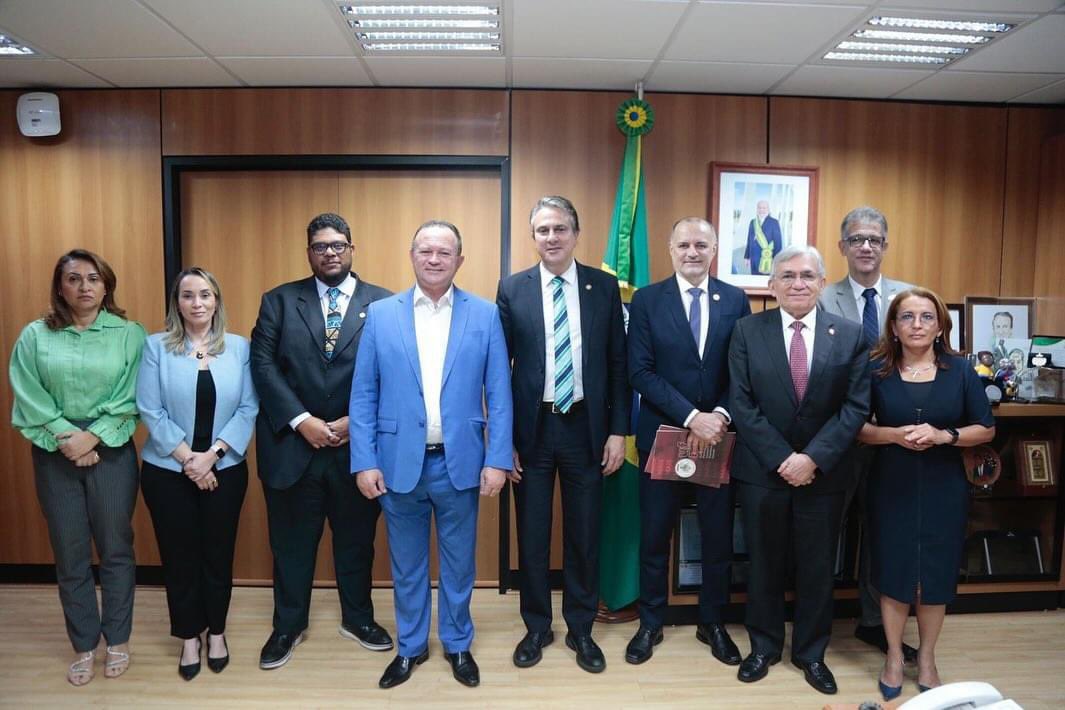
349, 220, 512, 688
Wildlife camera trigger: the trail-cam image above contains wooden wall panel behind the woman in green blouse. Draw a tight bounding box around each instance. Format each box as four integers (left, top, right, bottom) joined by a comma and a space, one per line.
0, 90, 163, 564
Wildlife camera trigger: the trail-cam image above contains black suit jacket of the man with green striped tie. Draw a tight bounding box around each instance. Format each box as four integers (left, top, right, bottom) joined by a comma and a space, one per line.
495, 264, 633, 460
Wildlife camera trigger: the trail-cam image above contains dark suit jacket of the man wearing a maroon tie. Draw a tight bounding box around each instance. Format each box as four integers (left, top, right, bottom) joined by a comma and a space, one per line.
728, 309, 870, 494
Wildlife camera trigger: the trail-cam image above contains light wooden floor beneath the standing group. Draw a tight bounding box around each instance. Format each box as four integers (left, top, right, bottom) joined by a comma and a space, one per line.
0, 585, 1065, 710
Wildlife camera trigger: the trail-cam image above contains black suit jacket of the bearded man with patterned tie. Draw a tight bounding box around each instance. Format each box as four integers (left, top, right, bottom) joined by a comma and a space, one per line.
251, 277, 391, 490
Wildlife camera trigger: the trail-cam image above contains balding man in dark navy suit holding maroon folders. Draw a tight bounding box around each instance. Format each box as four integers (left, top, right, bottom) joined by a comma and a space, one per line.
625, 217, 751, 665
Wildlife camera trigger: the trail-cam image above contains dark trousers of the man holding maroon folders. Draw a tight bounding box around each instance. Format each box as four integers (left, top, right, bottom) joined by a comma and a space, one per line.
639, 451, 733, 629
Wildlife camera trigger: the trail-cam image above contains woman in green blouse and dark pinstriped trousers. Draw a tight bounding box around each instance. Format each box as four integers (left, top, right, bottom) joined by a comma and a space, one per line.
11, 249, 145, 686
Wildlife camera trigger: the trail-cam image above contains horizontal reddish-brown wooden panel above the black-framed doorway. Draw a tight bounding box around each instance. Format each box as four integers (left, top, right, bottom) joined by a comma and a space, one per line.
162, 88, 509, 155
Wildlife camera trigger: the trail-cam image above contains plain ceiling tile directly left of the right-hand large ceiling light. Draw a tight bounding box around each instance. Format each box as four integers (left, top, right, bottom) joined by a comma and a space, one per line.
663, 2, 866, 64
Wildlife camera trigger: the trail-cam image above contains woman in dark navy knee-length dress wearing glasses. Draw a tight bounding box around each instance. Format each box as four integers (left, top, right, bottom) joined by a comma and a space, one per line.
858, 288, 995, 699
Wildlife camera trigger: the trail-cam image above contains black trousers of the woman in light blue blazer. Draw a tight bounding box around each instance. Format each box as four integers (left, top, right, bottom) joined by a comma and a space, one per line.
141, 461, 248, 639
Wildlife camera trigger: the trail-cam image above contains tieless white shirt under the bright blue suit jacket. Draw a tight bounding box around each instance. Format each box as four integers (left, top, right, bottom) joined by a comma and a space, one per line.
414, 285, 455, 444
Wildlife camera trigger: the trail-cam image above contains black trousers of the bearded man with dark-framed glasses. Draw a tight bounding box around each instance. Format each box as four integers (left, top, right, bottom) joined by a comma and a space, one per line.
263, 447, 381, 634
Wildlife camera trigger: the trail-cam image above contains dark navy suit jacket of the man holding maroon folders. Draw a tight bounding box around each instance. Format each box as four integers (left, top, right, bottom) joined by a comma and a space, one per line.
628, 275, 751, 451
